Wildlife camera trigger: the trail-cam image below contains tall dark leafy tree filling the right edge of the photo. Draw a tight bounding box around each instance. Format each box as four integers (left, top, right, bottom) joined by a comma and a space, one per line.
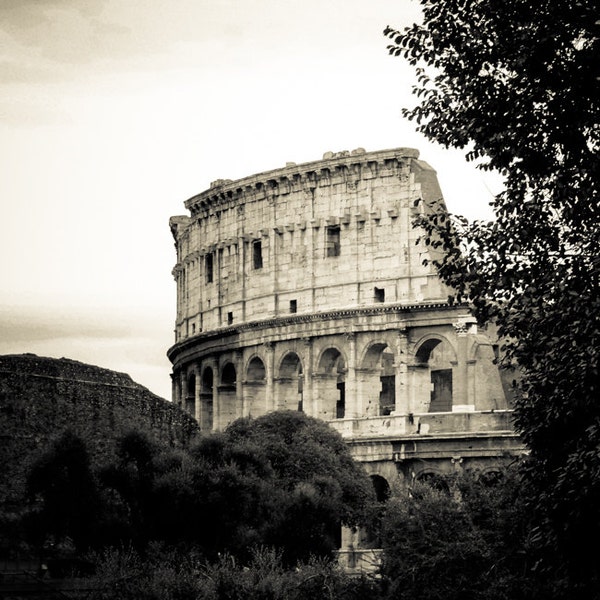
385, 0, 600, 593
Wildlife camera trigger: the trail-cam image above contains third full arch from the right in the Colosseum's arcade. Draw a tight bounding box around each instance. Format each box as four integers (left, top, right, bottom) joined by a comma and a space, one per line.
313, 346, 346, 420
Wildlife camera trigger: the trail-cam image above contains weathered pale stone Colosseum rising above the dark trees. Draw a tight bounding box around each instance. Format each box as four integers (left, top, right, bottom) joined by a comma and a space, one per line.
168, 148, 522, 564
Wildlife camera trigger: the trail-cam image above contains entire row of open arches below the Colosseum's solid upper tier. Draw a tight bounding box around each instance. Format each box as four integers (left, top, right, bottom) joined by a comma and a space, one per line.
174, 335, 478, 429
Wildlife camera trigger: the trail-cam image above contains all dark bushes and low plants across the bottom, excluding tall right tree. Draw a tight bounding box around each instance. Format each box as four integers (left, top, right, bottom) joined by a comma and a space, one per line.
15, 450, 572, 600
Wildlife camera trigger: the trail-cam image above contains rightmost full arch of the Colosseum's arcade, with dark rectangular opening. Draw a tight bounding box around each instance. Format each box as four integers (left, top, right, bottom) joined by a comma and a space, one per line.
413, 334, 457, 412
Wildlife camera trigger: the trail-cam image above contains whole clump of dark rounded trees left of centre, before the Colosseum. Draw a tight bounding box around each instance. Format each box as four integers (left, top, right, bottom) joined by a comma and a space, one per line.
19, 411, 373, 566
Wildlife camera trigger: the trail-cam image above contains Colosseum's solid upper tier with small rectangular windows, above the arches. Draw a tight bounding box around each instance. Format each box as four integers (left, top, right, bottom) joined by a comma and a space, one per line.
170, 148, 448, 344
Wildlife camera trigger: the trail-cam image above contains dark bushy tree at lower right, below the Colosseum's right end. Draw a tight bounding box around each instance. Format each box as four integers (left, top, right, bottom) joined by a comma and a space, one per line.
382, 467, 560, 600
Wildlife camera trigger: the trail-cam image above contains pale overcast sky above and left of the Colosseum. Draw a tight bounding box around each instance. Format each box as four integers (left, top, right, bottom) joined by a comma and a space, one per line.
0, 0, 498, 398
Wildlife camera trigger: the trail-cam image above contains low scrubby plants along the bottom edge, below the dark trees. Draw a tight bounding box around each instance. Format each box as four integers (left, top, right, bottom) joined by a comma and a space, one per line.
89, 548, 378, 600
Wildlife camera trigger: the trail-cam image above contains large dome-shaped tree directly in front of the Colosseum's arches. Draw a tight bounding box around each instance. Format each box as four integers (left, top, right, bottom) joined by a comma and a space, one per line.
225, 411, 375, 564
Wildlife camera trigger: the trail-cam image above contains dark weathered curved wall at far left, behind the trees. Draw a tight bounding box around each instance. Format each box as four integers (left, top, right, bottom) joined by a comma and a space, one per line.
0, 354, 198, 506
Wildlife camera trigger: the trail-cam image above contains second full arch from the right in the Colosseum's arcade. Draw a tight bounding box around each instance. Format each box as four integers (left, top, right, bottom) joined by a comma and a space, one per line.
357, 340, 396, 416
